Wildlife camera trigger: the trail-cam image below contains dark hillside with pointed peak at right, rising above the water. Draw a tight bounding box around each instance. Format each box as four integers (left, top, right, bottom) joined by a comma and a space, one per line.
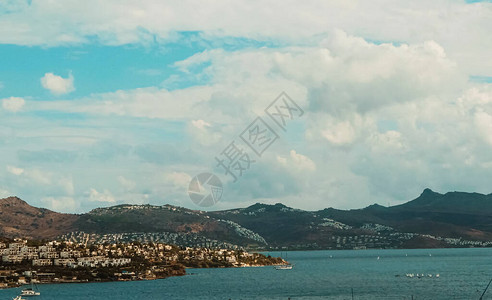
210, 189, 492, 248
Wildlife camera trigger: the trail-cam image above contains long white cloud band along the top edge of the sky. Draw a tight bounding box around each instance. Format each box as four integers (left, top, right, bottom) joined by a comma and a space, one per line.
0, 0, 492, 76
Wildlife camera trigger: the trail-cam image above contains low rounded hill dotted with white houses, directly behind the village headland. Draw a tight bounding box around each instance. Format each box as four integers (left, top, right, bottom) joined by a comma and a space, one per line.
73, 205, 265, 246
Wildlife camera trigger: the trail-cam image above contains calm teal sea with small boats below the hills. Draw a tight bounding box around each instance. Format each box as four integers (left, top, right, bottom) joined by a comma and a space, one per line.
0, 248, 492, 300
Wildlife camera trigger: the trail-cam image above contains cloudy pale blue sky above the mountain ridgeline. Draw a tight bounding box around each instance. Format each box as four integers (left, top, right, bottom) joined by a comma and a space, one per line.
0, 0, 492, 213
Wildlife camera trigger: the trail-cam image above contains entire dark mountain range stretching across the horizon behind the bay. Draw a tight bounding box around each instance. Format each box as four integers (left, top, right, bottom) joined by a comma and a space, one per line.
0, 189, 492, 249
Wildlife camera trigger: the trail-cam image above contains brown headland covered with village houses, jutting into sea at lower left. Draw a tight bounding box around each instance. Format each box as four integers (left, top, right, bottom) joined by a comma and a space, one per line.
0, 239, 285, 288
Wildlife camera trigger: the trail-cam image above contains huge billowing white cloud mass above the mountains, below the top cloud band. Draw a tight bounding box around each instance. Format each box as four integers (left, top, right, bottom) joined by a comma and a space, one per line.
18, 31, 484, 208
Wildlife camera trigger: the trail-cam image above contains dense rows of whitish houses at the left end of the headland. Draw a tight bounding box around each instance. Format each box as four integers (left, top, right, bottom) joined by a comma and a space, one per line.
0, 240, 131, 268
